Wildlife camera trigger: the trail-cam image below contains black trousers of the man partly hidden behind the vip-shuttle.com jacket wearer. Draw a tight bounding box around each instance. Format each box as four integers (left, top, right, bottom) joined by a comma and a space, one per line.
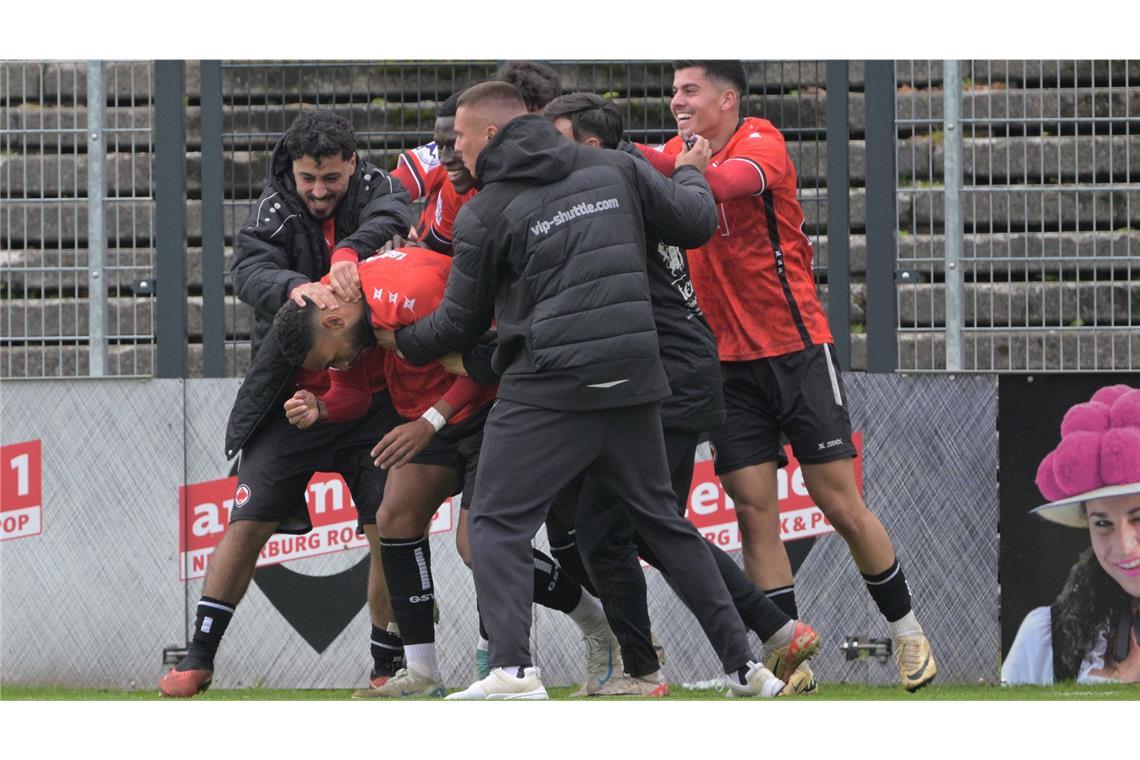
575, 428, 790, 676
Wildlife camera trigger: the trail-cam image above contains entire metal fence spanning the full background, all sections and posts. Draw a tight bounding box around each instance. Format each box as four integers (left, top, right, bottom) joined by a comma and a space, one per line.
0, 60, 1140, 377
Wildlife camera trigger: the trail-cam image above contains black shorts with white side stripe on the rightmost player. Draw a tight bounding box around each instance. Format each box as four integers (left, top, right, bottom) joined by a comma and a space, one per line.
709, 344, 856, 475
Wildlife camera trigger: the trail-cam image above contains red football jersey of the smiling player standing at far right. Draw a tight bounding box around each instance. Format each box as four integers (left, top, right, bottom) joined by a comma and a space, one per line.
656, 119, 833, 361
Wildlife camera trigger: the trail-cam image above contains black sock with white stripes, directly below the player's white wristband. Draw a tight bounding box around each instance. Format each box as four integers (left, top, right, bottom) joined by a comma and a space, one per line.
380, 537, 435, 645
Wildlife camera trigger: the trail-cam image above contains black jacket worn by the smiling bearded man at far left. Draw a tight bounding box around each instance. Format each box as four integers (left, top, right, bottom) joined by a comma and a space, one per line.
230, 142, 412, 353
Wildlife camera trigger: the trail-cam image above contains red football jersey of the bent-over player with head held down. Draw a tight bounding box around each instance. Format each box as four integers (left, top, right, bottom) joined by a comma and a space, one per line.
358, 248, 497, 424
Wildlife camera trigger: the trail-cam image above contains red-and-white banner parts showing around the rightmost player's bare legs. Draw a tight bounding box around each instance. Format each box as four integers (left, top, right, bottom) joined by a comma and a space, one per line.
686, 433, 863, 551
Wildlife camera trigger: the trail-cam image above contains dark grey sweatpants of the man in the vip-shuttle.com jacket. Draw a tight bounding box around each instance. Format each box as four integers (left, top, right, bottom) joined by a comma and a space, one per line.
471, 399, 754, 672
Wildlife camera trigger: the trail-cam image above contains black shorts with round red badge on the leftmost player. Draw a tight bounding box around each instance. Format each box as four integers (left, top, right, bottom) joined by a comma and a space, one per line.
229, 393, 404, 533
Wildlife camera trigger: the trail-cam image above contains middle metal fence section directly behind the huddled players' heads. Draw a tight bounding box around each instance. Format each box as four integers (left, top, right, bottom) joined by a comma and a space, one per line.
214, 60, 827, 374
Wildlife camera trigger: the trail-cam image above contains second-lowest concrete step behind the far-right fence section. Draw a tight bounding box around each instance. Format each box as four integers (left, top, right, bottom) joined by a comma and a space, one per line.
897, 279, 1140, 329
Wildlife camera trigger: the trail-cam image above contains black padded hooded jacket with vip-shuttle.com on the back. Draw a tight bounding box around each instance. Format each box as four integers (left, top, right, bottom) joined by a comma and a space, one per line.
397, 116, 717, 411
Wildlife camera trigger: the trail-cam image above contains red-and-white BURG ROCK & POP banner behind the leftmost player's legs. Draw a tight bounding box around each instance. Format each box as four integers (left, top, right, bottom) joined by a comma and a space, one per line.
178, 473, 451, 580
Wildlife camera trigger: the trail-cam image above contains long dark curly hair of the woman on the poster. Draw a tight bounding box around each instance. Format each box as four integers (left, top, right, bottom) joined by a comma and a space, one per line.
1053, 547, 1131, 676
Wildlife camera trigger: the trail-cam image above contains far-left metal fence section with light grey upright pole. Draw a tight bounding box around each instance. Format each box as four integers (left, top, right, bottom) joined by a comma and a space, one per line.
0, 62, 154, 377
